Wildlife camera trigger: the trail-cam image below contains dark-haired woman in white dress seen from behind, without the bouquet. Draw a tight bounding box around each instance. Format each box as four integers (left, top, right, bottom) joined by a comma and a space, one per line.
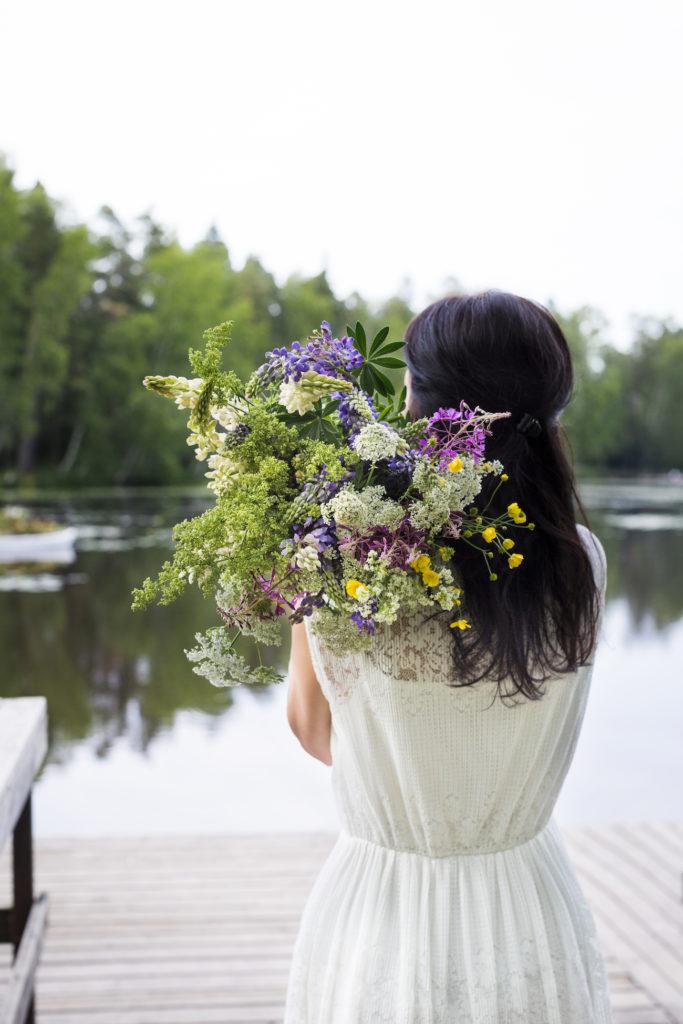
285, 292, 610, 1024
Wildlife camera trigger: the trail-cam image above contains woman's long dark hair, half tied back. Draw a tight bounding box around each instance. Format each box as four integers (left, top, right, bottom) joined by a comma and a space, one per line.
405, 291, 598, 699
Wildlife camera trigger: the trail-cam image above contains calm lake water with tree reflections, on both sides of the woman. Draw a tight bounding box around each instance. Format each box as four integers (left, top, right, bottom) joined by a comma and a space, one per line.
0, 481, 683, 836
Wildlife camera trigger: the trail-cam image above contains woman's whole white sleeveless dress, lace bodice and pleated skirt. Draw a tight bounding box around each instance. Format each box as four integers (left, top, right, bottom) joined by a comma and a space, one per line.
285, 525, 611, 1024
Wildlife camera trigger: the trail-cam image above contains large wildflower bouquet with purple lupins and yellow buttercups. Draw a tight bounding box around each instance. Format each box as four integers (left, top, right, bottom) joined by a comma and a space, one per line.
133, 322, 533, 686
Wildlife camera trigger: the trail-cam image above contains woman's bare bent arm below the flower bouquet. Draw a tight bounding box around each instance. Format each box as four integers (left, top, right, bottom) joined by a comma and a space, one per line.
287, 623, 332, 765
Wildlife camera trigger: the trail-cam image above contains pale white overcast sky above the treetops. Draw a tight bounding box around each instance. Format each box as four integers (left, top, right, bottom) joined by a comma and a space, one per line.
0, 0, 683, 342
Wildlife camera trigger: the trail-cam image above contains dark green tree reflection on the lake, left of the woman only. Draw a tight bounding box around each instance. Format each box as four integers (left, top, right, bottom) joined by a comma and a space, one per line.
0, 496, 284, 762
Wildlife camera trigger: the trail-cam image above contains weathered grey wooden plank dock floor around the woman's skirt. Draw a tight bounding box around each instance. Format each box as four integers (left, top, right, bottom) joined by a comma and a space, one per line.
0, 823, 683, 1024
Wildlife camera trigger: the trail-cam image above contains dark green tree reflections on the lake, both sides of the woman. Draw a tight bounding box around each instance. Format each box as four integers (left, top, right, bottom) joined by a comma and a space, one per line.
0, 484, 683, 764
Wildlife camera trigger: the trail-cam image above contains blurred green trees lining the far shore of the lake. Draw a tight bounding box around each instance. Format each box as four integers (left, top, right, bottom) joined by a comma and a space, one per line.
0, 164, 683, 486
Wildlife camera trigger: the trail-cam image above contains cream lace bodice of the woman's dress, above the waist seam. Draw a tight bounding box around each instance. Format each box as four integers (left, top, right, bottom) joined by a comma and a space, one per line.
308, 526, 605, 857
